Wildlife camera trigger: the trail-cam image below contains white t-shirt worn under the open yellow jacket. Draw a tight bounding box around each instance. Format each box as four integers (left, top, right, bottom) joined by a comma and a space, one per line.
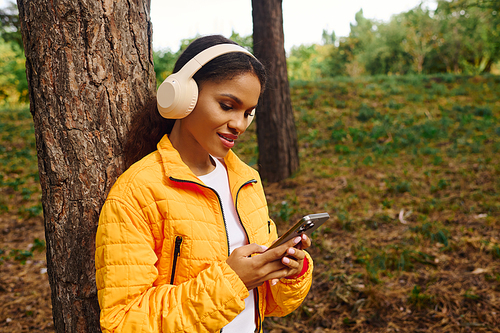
198, 157, 256, 333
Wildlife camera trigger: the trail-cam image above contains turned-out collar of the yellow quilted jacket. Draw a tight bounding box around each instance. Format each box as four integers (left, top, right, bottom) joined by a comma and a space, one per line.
157, 135, 255, 189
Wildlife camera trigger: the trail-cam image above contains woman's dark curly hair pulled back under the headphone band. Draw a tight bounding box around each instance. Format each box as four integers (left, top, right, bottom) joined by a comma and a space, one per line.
124, 35, 267, 168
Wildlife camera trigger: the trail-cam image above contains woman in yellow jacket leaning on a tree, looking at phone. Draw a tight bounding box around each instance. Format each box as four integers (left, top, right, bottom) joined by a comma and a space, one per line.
96, 36, 312, 332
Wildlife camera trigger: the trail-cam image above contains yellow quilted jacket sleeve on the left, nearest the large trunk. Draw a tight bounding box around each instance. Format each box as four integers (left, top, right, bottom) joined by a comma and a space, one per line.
96, 199, 249, 333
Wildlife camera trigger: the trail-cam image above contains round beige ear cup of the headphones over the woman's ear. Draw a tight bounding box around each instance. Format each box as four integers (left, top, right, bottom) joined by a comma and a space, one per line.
156, 74, 198, 119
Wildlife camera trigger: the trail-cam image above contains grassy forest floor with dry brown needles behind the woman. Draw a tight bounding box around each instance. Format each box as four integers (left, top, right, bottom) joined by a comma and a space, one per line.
0, 75, 500, 333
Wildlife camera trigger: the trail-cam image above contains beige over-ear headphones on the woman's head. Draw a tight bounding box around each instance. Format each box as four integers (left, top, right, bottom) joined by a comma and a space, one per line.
156, 44, 255, 124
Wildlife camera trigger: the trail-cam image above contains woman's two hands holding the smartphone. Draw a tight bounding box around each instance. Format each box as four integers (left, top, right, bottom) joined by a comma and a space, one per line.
226, 232, 311, 290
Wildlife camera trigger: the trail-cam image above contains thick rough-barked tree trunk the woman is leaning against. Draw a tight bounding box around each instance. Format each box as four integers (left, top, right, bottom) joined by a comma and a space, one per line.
18, 0, 156, 332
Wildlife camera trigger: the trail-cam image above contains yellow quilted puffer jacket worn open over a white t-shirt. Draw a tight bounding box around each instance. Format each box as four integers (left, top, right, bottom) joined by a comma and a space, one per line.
96, 136, 313, 333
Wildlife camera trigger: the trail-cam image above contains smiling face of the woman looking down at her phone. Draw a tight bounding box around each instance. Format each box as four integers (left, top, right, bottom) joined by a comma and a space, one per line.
176, 73, 261, 158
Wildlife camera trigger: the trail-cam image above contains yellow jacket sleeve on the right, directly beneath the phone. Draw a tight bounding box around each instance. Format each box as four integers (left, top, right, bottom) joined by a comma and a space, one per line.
263, 220, 313, 317
